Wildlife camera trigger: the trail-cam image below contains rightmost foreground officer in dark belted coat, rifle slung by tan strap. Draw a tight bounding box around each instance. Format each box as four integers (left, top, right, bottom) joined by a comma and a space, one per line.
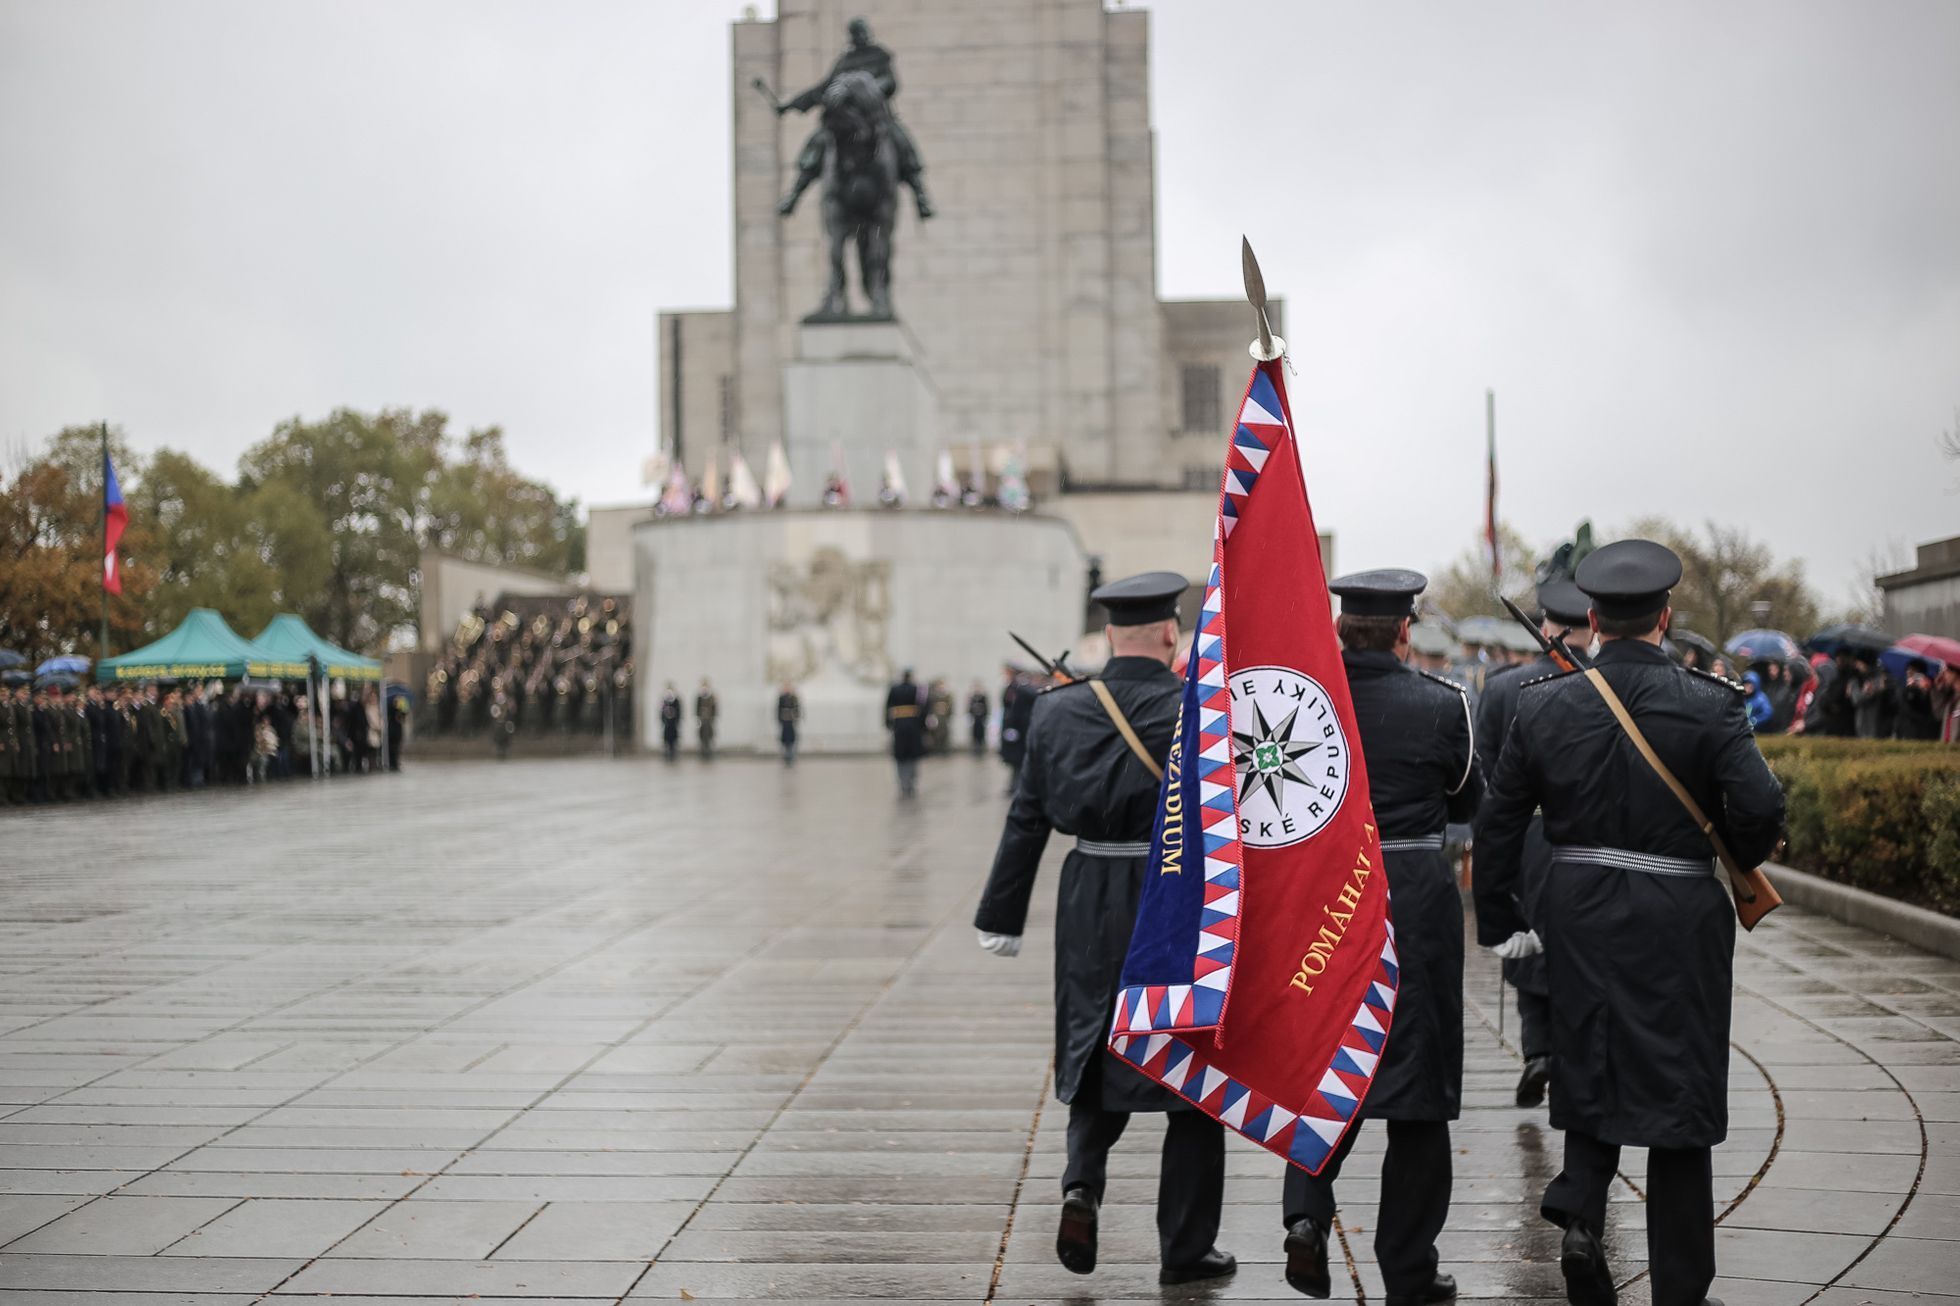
1476, 539, 1784, 1306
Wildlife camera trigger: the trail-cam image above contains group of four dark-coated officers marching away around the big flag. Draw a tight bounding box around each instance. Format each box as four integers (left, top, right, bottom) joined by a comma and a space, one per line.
974, 541, 1784, 1306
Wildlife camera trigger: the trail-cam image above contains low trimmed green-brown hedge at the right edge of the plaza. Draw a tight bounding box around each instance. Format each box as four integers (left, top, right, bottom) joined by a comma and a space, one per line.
1760, 735, 1960, 916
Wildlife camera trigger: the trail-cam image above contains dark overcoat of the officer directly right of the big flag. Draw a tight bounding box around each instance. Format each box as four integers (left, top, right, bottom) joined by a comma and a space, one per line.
1341, 651, 1484, 1120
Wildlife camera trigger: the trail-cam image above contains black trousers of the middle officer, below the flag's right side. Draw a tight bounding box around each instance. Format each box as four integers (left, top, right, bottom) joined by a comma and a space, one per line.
1282, 1120, 1450, 1296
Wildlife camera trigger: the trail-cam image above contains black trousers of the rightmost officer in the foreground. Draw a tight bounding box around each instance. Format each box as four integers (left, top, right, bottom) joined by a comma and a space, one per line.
1543, 1130, 1715, 1306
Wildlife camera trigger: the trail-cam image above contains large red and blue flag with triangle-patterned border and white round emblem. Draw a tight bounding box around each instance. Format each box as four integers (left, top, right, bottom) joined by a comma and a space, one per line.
1109, 361, 1397, 1173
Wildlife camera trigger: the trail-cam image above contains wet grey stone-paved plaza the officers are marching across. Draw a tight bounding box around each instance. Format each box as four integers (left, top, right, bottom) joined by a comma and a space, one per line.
0, 757, 1960, 1306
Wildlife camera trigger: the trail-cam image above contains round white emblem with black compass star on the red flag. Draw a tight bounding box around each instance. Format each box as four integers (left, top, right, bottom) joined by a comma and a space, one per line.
1231, 667, 1348, 847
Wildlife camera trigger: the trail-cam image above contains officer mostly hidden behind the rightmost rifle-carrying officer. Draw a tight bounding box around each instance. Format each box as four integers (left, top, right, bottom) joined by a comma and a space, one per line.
1476, 578, 1592, 1106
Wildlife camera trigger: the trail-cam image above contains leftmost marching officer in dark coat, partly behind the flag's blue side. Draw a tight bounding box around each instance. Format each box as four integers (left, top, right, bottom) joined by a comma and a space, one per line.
974, 571, 1237, 1282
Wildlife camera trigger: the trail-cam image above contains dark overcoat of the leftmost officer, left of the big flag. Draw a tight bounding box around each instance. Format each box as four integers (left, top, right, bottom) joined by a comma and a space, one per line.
974, 657, 1184, 1112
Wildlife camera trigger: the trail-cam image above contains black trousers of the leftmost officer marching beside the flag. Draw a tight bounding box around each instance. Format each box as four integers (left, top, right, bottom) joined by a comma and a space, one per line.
1062, 1088, 1225, 1269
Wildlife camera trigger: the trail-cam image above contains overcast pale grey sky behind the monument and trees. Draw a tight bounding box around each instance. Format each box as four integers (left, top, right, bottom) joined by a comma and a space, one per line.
0, 0, 1960, 602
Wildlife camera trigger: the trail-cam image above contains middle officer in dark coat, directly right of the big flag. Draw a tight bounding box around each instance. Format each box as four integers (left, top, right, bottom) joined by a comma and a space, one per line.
1284, 569, 1484, 1306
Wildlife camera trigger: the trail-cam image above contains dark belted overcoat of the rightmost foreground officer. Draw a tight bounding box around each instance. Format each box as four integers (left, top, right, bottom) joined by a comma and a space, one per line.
1476, 639, 1784, 1147
